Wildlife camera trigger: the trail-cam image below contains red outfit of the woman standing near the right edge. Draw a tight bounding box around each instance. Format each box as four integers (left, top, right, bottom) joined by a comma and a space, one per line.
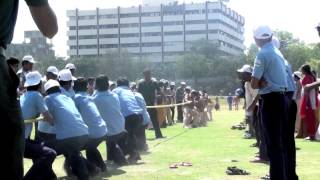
300, 75, 318, 138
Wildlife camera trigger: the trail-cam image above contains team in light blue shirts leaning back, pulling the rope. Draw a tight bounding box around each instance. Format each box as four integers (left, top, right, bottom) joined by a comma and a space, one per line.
10, 59, 150, 180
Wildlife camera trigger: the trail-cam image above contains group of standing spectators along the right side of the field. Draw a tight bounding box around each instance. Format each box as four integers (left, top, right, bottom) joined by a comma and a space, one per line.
237, 26, 320, 180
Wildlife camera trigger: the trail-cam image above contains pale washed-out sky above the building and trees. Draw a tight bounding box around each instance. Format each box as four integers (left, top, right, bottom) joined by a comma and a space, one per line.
13, 0, 320, 56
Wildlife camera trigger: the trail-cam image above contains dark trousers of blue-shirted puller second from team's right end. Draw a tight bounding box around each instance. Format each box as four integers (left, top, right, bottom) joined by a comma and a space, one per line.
125, 114, 143, 155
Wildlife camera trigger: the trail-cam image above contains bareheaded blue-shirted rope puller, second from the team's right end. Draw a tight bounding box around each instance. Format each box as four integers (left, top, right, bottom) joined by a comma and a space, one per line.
112, 78, 143, 162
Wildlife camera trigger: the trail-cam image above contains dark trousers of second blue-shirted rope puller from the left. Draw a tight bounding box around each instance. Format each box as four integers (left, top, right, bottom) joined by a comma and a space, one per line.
47, 135, 89, 180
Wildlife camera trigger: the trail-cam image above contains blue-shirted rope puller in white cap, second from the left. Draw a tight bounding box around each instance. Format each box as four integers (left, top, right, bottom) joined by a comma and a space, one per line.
44, 79, 89, 179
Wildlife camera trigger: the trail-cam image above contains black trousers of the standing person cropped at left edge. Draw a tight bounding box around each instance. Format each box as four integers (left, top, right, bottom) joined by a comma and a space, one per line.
0, 54, 25, 180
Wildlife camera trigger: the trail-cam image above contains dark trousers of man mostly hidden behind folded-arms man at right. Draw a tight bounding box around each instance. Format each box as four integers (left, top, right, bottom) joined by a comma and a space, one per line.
286, 92, 299, 180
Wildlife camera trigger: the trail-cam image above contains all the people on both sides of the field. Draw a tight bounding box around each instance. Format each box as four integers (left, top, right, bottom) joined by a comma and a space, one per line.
0, 0, 320, 180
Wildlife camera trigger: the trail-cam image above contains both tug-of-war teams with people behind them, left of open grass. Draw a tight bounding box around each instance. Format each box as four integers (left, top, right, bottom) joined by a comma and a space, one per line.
7, 52, 218, 179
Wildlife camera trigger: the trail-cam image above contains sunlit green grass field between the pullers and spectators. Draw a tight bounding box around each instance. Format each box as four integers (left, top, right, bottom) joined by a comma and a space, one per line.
25, 105, 320, 180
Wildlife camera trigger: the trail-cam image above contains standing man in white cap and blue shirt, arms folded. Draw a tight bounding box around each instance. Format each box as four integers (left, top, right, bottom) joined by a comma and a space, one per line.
251, 26, 290, 180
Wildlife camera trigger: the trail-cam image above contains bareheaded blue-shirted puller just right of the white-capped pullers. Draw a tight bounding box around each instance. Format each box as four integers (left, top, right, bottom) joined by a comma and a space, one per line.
74, 77, 107, 172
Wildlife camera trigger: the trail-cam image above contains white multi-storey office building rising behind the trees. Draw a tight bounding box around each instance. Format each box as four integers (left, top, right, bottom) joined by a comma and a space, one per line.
67, 1, 245, 62
